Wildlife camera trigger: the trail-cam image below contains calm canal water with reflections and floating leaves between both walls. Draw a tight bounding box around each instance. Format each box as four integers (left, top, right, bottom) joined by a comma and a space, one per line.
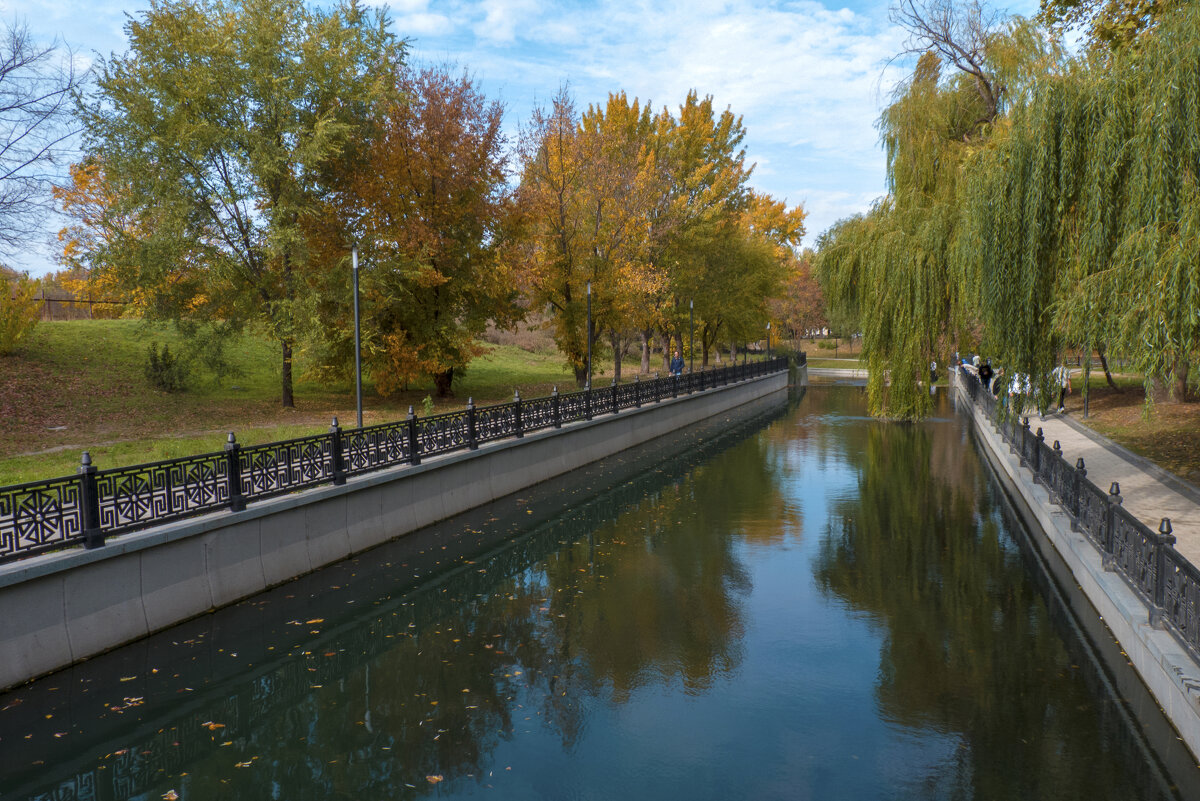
0, 387, 1200, 801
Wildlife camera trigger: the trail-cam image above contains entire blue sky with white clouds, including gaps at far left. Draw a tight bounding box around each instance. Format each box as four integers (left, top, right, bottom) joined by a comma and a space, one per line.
0, 0, 1036, 275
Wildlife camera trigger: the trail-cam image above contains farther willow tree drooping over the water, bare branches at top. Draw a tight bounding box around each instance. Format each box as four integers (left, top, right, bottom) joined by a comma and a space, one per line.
817, 0, 1061, 418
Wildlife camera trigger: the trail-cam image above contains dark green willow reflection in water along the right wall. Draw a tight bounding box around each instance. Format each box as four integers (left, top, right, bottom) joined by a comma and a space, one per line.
815, 393, 1174, 799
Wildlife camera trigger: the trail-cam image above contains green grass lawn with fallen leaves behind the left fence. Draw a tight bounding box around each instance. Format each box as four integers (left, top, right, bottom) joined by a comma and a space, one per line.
0, 320, 583, 486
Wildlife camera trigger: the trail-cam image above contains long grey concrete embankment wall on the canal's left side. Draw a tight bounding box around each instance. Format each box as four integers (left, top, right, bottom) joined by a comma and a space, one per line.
0, 372, 788, 688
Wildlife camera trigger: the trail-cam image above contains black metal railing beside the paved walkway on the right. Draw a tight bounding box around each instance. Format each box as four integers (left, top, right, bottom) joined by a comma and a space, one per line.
959, 371, 1200, 658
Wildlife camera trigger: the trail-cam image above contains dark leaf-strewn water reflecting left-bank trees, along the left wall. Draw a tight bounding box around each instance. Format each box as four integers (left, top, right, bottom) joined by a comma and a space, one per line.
0, 402, 782, 799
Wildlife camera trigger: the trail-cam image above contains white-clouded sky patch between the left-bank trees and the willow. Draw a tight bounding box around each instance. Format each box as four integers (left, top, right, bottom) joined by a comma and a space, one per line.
418, 0, 902, 241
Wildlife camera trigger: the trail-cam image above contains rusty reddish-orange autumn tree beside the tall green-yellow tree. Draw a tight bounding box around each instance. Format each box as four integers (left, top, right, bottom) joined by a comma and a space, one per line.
308, 66, 522, 397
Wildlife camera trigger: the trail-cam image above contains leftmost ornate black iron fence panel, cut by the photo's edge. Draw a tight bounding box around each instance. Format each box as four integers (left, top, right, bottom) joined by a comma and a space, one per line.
0, 476, 83, 561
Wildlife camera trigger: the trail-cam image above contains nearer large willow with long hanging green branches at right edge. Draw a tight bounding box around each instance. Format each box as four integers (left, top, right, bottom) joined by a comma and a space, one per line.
964, 6, 1200, 407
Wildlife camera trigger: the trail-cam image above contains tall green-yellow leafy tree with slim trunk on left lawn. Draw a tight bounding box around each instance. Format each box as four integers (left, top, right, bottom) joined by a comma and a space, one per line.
80, 0, 403, 406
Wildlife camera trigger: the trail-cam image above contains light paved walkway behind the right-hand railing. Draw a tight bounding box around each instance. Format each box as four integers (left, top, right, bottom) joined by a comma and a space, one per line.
960, 371, 1200, 566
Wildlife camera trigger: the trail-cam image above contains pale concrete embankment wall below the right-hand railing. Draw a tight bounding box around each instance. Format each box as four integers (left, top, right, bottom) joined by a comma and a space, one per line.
955, 383, 1200, 759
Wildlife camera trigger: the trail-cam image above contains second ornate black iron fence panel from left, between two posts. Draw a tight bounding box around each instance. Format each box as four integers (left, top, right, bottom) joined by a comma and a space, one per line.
96, 453, 229, 534
